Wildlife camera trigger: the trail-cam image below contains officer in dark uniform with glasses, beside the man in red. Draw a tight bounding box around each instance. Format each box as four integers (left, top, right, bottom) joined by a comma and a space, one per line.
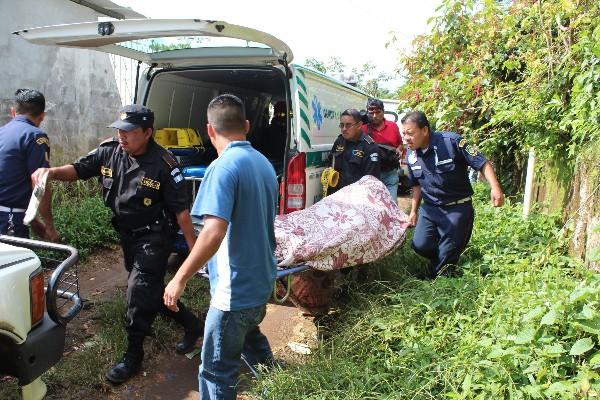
328, 108, 379, 194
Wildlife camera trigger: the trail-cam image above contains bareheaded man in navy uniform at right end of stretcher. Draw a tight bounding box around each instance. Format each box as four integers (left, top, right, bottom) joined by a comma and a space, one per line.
401, 111, 504, 277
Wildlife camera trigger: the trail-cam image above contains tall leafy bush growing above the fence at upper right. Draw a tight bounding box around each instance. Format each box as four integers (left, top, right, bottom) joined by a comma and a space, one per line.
398, 0, 600, 193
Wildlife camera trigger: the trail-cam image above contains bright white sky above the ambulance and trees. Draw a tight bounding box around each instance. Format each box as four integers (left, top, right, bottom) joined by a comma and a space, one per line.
112, 0, 441, 89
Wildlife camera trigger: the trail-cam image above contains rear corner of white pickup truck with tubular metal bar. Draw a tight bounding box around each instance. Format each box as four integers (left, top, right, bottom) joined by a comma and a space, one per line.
0, 235, 82, 400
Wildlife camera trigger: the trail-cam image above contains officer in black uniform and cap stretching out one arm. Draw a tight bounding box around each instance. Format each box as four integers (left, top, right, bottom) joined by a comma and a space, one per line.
33, 105, 204, 383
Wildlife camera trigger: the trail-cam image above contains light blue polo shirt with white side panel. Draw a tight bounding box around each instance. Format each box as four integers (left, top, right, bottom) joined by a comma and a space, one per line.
192, 141, 278, 311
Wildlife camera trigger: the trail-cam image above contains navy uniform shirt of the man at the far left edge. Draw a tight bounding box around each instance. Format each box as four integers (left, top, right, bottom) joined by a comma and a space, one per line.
0, 115, 50, 208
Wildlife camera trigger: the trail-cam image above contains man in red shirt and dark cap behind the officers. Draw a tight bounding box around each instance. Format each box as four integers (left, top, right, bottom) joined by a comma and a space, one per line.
362, 99, 402, 200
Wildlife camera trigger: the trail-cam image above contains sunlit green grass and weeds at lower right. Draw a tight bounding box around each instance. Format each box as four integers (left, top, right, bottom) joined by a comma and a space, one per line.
256, 189, 600, 399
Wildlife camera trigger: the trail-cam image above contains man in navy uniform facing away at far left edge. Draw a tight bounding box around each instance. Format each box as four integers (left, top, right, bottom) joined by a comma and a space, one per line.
0, 89, 58, 242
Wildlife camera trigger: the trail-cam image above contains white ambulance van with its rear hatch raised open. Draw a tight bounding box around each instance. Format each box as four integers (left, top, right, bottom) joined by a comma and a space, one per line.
14, 19, 368, 214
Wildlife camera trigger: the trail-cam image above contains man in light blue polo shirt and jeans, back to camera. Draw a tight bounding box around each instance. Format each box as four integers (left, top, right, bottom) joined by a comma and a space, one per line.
164, 94, 278, 400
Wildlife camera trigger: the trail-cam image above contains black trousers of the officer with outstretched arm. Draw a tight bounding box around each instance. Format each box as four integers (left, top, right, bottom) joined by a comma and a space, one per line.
121, 232, 197, 356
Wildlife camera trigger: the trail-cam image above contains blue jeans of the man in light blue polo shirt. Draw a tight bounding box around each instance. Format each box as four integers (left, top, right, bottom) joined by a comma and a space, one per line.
198, 304, 273, 400
